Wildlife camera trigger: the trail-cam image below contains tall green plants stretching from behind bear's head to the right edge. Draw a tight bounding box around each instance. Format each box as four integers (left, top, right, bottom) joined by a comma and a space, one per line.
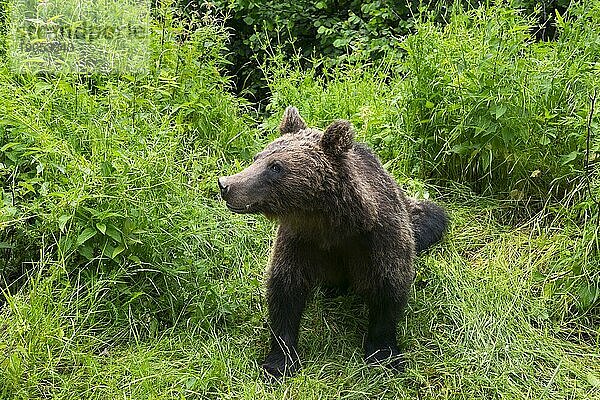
266, 4, 600, 206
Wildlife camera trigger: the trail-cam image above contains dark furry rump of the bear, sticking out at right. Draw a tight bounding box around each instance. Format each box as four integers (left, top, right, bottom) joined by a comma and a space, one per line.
408, 199, 449, 254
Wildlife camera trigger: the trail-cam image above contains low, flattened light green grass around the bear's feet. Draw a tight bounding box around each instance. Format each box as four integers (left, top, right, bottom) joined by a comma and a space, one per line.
0, 198, 600, 399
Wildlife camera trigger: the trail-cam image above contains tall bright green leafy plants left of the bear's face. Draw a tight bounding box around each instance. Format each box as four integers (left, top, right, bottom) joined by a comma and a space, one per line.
0, 5, 262, 334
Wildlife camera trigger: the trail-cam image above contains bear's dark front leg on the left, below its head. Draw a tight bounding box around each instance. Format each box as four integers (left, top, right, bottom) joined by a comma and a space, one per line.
263, 264, 310, 378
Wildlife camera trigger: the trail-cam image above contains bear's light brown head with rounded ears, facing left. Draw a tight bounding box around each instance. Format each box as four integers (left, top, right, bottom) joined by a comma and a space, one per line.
218, 107, 354, 218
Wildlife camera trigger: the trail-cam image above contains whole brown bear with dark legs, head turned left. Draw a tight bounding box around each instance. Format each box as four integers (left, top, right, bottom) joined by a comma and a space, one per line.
218, 107, 448, 377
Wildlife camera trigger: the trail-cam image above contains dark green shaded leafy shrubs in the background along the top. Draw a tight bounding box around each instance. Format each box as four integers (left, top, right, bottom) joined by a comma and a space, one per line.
186, 0, 570, 97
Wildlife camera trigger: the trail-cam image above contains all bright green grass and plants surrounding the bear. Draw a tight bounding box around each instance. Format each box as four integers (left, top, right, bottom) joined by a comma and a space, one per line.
0, 0, 600, 399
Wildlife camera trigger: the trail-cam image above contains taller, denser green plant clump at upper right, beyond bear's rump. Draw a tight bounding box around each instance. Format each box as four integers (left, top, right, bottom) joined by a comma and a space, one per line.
403, 3, 600, 200
